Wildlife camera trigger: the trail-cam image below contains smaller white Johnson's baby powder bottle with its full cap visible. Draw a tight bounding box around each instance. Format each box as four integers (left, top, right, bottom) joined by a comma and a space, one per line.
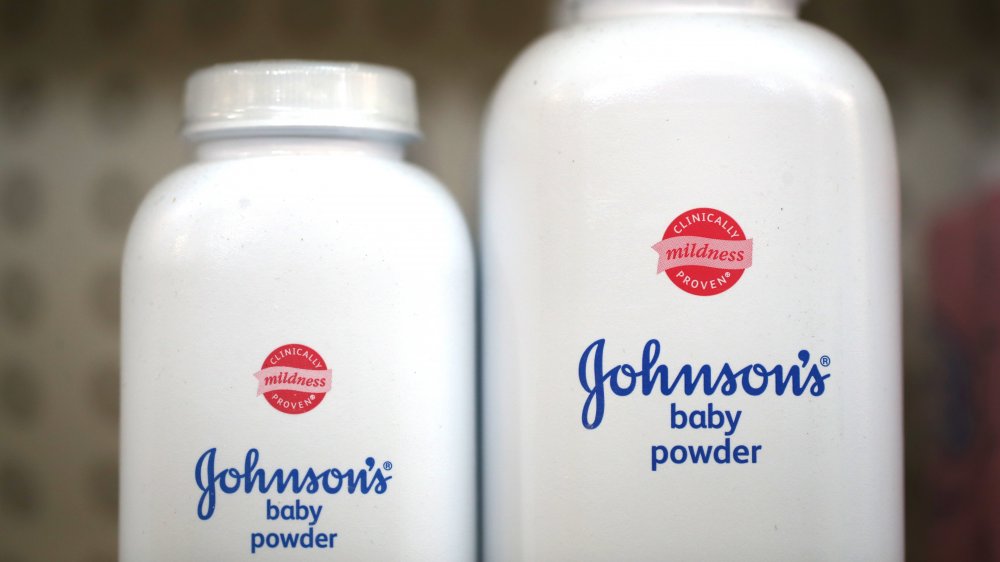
120, 61, 475, 560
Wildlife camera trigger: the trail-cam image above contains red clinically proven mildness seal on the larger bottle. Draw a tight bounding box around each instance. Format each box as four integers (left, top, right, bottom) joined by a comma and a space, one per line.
653, 208, 753, 297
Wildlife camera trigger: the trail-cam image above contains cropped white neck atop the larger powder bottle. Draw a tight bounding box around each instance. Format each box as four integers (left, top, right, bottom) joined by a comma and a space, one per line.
567, 0, 802, 22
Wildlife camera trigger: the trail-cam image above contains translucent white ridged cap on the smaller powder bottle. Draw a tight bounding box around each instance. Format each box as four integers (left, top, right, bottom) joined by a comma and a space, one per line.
184, 60, 420, 140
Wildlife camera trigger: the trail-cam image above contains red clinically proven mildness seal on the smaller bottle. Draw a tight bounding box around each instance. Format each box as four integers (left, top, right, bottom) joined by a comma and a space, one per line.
254, 343, 331, 414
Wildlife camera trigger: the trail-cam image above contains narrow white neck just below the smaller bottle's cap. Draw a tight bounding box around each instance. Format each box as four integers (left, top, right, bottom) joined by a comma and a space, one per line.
195, 136, 406, 161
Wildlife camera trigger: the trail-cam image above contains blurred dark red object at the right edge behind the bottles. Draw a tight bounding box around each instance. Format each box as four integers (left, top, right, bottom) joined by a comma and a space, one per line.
928, 188, 1000, 562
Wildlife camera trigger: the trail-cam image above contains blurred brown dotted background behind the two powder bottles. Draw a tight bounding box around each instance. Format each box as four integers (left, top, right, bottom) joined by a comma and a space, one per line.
0, 0, 1000, 562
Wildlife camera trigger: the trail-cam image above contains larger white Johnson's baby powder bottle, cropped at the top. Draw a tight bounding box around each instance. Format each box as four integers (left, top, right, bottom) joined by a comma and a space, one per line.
482, 0, 903, 562
